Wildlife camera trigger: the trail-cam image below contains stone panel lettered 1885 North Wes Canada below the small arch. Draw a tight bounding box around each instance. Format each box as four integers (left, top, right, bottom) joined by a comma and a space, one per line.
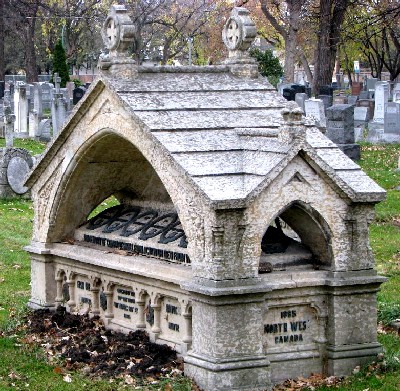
264, 305, 318, 351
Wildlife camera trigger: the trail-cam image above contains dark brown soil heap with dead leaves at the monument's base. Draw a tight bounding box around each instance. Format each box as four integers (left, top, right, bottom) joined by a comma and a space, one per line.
27, 307, 183, 386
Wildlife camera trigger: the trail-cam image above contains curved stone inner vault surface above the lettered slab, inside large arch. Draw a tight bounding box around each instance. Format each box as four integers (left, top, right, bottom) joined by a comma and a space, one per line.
48, 129, 173, 242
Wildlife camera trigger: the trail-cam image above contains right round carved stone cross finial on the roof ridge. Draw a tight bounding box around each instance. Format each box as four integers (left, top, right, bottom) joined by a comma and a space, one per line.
222, 7, 257, 57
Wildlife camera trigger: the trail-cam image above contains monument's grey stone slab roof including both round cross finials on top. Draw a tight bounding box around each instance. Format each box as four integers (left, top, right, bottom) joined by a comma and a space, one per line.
24, 6, 385, 208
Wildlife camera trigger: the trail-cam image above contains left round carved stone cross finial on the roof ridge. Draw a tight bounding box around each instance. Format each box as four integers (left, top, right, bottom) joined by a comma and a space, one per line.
102, 5, 136, 53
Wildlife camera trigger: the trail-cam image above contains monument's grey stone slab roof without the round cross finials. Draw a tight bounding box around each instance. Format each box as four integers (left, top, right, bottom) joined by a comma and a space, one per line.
28, 66, 385, 207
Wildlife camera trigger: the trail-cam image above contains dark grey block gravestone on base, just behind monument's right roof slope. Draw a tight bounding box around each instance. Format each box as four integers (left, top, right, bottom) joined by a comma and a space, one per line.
326, 105, 361, 160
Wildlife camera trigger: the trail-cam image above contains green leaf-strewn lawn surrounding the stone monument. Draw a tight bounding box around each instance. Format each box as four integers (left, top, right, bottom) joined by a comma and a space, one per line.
0, 139, 400, 391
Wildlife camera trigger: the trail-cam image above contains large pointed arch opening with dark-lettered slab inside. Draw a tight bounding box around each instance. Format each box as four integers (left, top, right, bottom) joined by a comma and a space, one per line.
50, 131, 189, 263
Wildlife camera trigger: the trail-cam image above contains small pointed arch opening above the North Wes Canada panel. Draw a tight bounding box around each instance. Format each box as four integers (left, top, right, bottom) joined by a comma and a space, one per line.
259, 201, 332, 273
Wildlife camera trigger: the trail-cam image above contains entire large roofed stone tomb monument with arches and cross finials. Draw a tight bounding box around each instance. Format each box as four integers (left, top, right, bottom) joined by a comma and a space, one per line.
26, 5, 385, 391
